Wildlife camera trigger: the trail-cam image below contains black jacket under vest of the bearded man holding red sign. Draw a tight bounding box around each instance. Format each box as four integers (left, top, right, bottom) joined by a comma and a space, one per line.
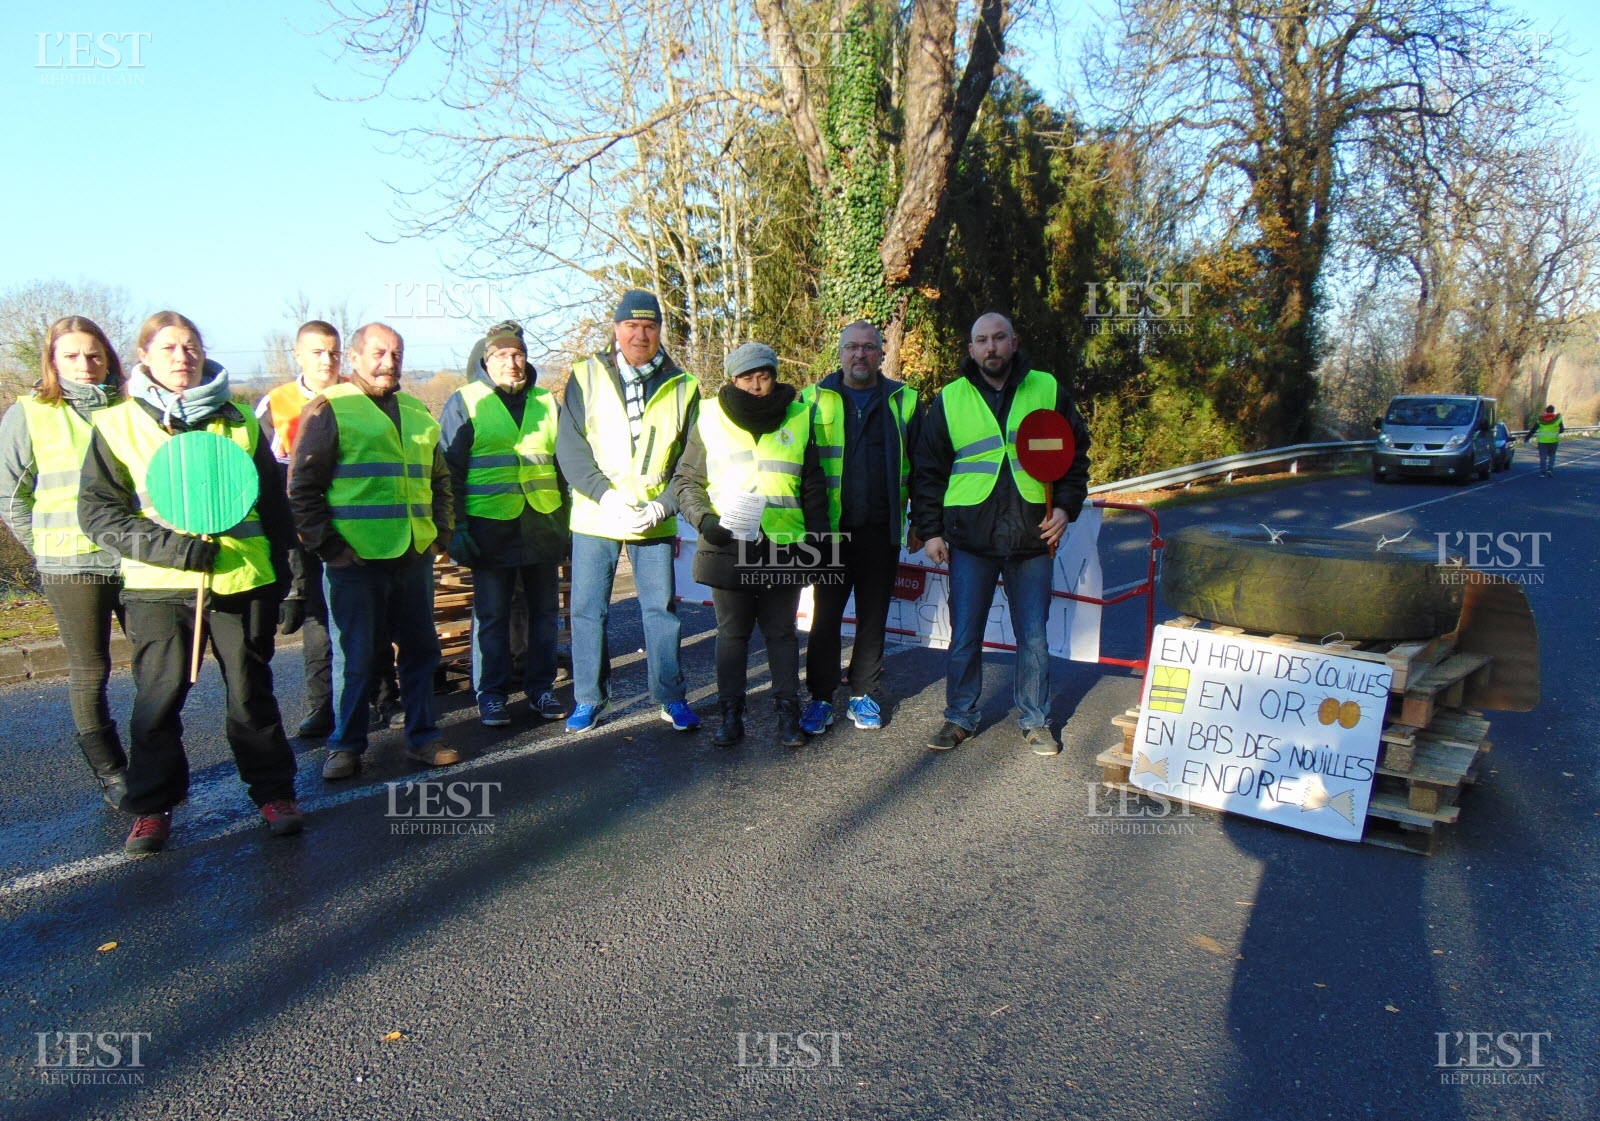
910, 350, 1090, 558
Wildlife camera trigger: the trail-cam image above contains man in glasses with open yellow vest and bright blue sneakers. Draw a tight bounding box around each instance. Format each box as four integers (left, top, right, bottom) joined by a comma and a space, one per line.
800, 320, 922, 736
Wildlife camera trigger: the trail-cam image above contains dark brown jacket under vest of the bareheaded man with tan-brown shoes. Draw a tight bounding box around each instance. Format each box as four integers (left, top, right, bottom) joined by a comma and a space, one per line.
290, 393, 454, 568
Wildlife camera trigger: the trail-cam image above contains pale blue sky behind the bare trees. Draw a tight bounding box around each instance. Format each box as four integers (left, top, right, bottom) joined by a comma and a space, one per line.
0, 0, 1600, 374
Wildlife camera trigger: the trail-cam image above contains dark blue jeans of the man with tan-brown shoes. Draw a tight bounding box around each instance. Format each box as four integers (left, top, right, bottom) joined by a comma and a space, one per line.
322, 560, 440, 752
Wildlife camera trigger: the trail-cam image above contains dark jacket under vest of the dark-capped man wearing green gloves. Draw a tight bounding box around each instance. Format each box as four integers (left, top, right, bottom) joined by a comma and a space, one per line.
438, 363, 571, 568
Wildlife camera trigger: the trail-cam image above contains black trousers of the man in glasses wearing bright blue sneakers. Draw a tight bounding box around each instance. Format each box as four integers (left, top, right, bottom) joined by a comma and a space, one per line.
805, 529, 899, 704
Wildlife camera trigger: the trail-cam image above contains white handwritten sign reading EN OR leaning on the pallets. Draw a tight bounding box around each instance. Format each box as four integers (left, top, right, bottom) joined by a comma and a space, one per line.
1130, 627, 1394, 841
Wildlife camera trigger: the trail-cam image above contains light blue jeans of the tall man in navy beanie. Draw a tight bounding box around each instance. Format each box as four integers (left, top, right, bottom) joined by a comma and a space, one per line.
573, 533, 685, 705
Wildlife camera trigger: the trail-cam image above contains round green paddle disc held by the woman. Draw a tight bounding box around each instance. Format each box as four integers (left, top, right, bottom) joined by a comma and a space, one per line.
144, 432, 261, 534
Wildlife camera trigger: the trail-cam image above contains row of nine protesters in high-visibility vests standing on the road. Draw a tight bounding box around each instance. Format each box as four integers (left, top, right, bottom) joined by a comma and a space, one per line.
0, 289, 1088, 856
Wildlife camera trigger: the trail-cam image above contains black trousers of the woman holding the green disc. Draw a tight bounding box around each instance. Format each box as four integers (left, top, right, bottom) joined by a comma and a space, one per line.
122, 592, 294, 814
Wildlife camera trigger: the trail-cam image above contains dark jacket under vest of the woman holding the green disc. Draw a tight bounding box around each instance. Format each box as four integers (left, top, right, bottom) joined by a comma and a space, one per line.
78, 400, 294, 603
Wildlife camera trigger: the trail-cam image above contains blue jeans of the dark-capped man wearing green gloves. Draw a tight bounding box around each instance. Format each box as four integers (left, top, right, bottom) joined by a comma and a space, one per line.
472, 564, 562, 704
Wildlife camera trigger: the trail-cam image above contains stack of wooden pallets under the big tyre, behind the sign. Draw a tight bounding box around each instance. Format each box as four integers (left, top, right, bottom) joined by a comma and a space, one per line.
1094, 616, 1493, 856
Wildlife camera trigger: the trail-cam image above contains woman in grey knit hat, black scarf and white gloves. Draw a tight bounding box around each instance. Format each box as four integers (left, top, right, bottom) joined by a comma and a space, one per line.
672, 342, 830, 747
